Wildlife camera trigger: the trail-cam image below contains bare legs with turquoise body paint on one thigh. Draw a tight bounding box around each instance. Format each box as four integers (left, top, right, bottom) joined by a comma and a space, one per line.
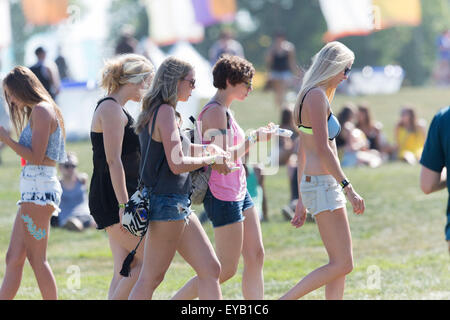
0, 203, 58, 300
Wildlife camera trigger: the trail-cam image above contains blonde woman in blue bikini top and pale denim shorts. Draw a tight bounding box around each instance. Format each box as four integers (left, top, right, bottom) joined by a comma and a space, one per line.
282, 41, 365, 299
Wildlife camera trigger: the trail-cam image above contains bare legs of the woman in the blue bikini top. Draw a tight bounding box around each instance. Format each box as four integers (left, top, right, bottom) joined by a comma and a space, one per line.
281, 208, 353, 300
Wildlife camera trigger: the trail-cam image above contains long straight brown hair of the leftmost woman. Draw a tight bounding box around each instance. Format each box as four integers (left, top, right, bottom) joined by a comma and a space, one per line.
3, 66, 66, 137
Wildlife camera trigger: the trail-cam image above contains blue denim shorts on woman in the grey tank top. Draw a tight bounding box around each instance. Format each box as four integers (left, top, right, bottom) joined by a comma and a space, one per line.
143, 188, 192, 223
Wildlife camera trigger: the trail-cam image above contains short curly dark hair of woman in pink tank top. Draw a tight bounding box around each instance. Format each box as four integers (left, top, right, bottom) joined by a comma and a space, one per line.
213, 55, 255, 89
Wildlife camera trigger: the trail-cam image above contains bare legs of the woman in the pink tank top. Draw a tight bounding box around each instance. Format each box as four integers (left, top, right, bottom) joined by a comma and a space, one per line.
173, 207, 264, 300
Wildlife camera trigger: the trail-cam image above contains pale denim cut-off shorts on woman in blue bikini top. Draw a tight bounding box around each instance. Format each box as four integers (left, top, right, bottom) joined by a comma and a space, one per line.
300, 174, 347, 217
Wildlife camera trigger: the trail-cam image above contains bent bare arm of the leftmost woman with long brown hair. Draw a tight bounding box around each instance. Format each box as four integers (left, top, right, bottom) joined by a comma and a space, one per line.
0, 105, 52, 165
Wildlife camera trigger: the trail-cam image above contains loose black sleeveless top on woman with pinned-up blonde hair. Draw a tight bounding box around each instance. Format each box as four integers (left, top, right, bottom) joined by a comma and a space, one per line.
89, 97, 141, 214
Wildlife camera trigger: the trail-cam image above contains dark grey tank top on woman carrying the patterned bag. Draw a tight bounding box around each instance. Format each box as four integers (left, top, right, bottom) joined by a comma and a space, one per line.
139, 107, 191, 195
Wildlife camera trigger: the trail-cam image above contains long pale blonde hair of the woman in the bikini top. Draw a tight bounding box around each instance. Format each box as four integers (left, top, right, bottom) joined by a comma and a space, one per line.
294, 41, 355, 126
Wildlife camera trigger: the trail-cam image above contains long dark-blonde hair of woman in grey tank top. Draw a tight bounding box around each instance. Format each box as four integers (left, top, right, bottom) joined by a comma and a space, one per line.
135, 57, 193, 134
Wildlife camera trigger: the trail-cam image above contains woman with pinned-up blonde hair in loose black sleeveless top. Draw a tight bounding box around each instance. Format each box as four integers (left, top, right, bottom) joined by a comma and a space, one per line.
89, 54, 154, 299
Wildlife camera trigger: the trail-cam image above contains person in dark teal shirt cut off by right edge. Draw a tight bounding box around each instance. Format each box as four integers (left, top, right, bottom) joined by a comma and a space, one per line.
420, 107, 450, 252
